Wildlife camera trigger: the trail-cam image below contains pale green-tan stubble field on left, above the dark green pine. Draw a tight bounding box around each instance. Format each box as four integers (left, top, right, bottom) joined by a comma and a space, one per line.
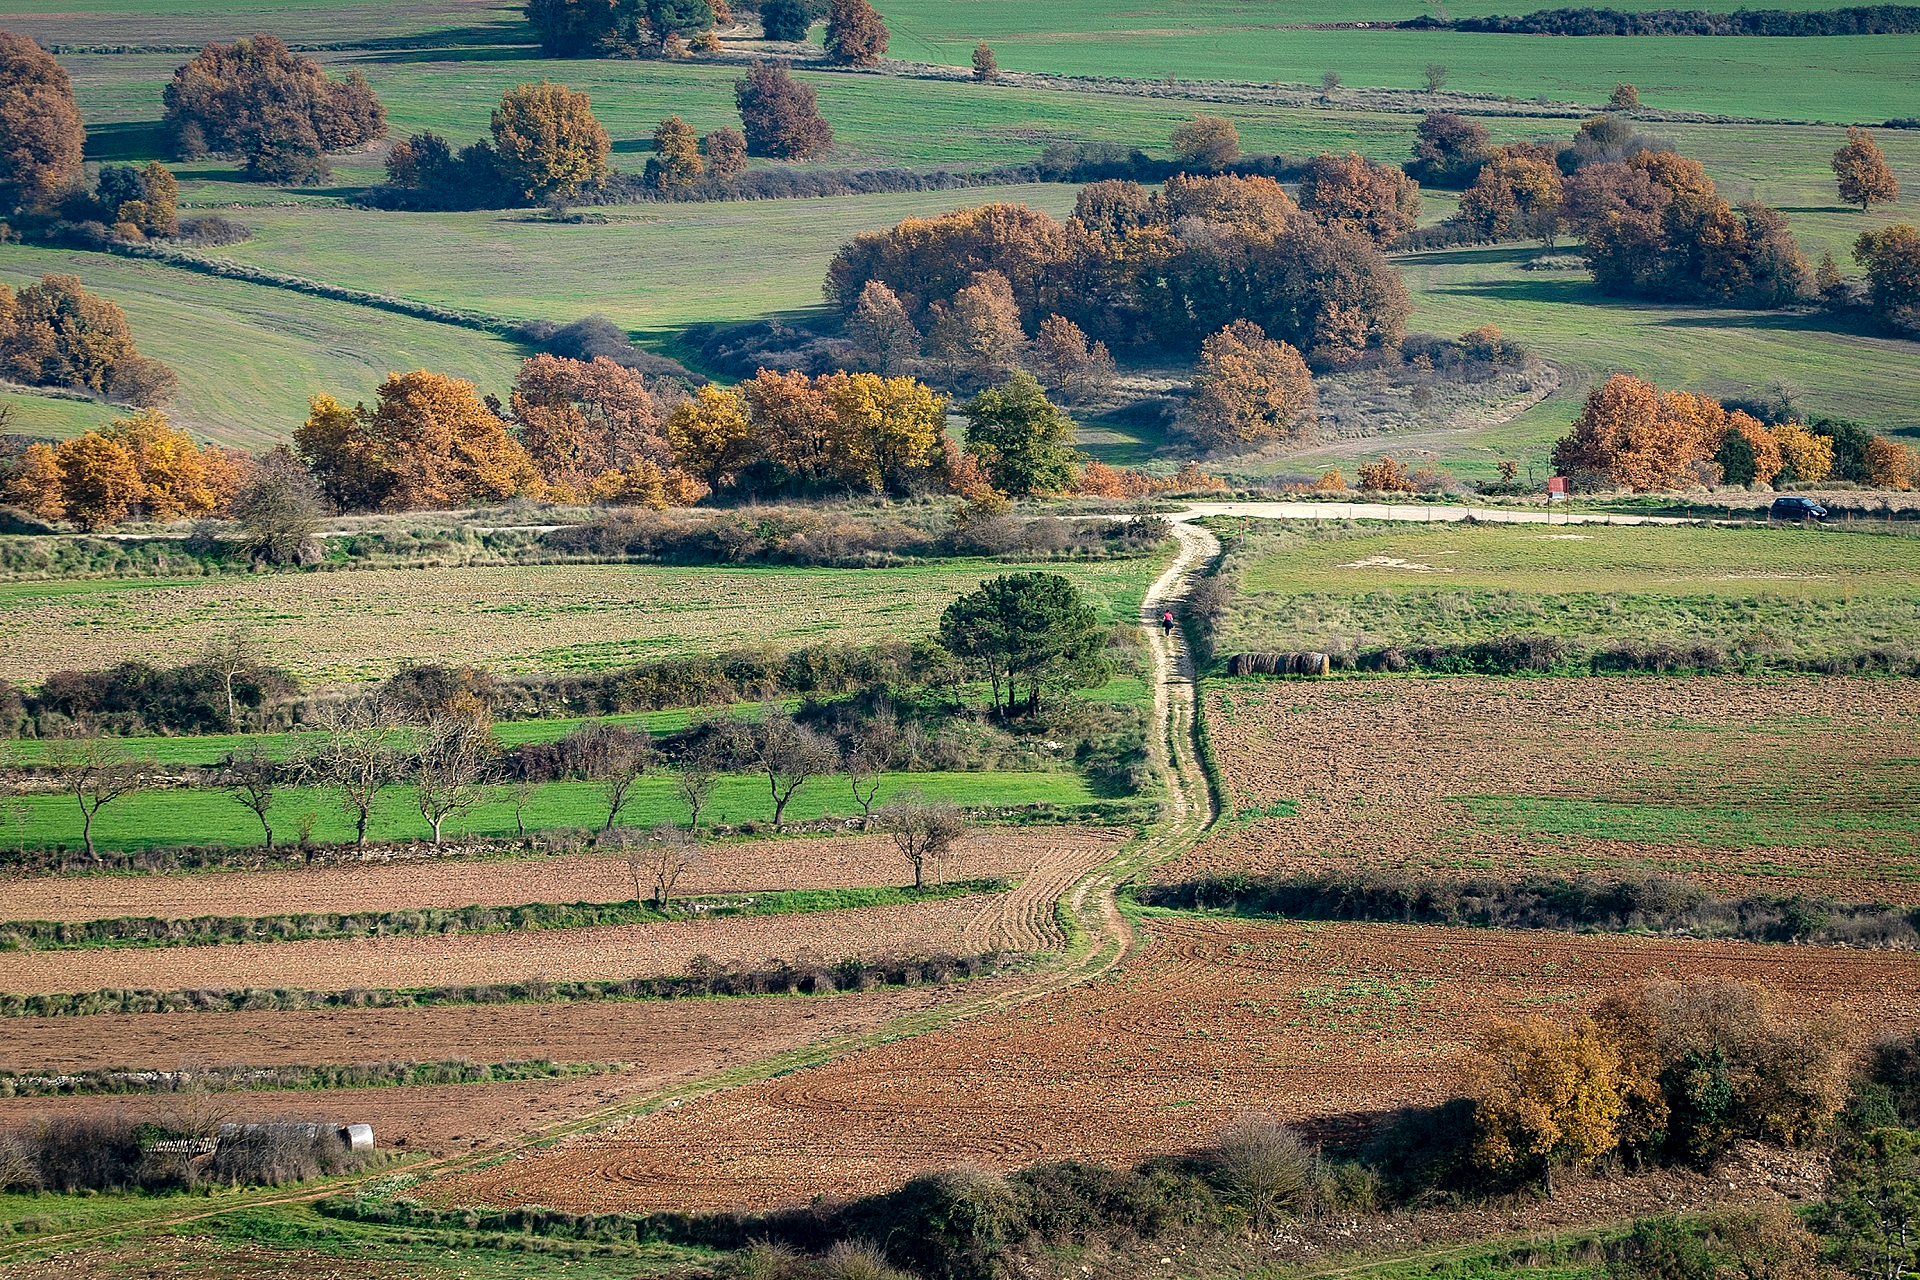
0, 557, 1160, 681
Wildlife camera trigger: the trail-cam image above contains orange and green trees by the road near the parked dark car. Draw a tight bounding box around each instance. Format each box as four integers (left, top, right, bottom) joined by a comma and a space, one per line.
1553, 374, 1914, 493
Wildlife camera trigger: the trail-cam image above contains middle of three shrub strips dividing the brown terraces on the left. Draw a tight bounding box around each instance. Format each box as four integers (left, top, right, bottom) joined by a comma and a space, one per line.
0, 952, 1006, 1017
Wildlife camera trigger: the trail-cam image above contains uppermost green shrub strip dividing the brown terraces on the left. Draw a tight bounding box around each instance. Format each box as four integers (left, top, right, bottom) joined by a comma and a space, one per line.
0, 881, 1006, 952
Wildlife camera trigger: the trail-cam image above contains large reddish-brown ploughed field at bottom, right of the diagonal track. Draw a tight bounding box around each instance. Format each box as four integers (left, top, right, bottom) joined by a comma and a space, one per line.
434, 917, 1920, 1209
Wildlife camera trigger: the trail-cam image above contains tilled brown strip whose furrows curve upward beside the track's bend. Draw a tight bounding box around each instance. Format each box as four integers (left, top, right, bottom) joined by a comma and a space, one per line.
0, 829, 1123, 992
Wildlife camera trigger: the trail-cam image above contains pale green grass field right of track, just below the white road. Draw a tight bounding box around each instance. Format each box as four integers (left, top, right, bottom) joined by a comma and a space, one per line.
1217, 524, 1920, 658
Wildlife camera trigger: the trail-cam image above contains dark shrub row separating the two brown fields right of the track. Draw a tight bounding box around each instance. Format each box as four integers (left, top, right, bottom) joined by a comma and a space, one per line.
1137, 873, 1920, 948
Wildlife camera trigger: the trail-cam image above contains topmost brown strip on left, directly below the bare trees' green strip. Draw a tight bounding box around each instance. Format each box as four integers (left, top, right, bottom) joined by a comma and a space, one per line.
0, 829, 1059, 921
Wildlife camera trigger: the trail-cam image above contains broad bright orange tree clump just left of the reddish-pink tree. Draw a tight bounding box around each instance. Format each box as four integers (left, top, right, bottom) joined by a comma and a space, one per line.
294, 368, 534, 510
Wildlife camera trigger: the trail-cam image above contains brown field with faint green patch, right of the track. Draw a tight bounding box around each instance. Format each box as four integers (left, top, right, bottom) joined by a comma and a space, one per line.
1156, 677, 1920, 904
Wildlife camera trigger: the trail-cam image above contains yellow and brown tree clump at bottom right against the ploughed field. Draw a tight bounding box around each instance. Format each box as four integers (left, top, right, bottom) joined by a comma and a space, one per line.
1469, 983, 1851, 1186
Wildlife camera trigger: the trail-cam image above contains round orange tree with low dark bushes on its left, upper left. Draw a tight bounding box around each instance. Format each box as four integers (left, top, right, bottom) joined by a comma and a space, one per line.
386, 81, 612, 209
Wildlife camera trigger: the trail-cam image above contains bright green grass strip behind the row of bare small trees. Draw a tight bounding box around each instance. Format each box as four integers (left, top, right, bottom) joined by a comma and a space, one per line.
0, 771, 1098, 850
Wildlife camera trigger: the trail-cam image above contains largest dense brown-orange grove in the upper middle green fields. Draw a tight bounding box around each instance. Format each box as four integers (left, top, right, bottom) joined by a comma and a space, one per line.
826, 163, 1409, 367
